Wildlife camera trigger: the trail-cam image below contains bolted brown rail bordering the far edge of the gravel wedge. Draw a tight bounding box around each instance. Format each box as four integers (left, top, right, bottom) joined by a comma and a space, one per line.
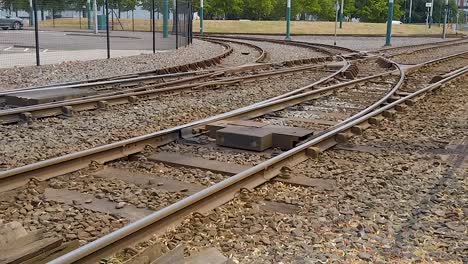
0, 62, 341, 125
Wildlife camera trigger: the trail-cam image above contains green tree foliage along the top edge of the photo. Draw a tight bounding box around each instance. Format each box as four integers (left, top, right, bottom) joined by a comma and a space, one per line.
0, 0, 457, 23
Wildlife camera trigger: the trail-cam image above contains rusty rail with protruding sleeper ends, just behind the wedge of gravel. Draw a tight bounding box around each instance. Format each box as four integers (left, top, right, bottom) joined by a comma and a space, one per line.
0, 63, 349, 124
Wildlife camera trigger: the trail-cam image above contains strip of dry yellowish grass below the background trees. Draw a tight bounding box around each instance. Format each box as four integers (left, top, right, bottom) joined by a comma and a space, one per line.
40, 18, 458, 35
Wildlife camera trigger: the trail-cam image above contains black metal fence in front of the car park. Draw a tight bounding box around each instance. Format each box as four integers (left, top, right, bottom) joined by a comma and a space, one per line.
0, 0, 193, 68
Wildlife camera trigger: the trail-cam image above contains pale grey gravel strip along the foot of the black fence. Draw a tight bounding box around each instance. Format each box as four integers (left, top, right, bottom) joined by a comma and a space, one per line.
0, 39, 224, 91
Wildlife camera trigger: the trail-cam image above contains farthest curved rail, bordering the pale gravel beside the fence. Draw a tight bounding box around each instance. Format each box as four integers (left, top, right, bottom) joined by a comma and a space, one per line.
0, 40, 233, 96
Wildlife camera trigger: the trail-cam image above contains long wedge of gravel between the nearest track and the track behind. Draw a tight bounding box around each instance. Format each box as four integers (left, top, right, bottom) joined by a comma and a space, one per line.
0, 71, 329, 170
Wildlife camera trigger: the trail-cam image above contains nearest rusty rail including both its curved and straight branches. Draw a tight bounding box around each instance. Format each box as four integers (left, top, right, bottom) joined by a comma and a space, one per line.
46, 52, 468, 264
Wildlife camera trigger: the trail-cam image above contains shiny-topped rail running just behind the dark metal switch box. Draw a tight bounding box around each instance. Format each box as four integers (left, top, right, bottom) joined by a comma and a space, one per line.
0, 59, 358, 192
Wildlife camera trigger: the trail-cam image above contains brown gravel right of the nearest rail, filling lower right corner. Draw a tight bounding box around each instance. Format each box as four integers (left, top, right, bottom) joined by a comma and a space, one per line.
152, 69, 468, 263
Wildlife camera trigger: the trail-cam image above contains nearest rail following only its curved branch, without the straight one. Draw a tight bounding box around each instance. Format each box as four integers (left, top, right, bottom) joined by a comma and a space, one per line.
45, 58, 404, 264
